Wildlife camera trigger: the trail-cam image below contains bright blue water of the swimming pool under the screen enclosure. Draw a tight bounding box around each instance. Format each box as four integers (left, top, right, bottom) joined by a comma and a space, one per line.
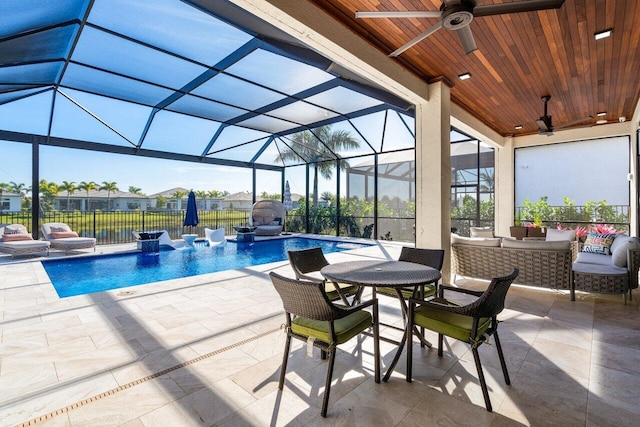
42, 237, 367, 298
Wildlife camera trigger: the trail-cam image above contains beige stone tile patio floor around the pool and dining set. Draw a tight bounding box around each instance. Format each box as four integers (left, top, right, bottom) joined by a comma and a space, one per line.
0, 239, 640, 427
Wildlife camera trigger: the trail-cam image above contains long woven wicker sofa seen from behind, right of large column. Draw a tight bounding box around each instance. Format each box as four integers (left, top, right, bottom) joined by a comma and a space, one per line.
451, 234, 578, 290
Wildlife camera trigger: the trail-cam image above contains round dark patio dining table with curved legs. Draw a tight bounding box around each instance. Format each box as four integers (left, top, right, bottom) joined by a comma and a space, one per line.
320, 260, 441, 382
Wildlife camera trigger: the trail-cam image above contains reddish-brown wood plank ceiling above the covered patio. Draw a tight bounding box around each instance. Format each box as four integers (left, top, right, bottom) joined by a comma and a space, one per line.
311, 0, 640, 136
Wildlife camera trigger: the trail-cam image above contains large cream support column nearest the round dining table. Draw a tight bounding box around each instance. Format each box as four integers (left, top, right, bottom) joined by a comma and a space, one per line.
416, 80, 451, 282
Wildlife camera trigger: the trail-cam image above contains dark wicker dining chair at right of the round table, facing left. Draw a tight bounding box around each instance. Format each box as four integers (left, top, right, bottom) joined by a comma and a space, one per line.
407, 268, 518, 412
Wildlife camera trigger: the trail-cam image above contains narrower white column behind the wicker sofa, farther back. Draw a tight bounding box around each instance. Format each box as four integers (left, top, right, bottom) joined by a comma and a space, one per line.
494, 137, 515, 236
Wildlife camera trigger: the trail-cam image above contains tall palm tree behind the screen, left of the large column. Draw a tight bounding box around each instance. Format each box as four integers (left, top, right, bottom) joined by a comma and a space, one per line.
275, 126, 360, 205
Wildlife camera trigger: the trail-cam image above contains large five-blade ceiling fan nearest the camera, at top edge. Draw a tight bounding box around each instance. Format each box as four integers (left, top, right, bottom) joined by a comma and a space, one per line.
356, 0, 564, 57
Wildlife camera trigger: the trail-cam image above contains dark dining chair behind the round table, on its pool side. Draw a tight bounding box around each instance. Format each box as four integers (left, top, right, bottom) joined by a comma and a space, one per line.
287, 246, 361, 305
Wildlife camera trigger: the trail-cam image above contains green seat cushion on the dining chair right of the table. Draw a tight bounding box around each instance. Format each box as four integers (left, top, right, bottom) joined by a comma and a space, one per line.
413, 298, 491, 344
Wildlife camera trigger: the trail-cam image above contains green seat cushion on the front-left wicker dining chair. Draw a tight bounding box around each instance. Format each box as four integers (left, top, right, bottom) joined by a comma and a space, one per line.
291, 310, 373, 345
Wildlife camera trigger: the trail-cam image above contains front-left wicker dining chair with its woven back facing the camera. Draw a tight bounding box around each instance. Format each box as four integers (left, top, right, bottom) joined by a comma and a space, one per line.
269, 272, 380, 417
